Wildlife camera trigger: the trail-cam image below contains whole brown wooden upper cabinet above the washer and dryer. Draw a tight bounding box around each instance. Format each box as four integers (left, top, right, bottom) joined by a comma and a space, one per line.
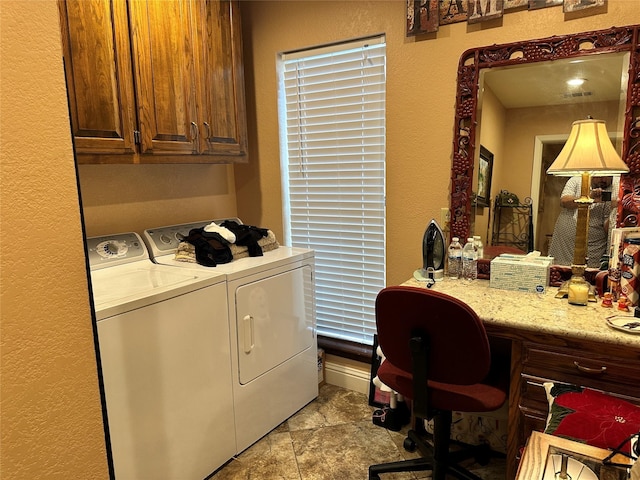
60, 0, 247, 163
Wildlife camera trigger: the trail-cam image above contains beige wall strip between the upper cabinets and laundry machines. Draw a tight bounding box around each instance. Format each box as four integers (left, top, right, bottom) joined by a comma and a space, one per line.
79, 165, 237, 237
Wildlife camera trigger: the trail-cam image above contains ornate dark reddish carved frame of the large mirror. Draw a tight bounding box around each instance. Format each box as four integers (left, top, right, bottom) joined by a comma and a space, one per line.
450, 25, 640, 248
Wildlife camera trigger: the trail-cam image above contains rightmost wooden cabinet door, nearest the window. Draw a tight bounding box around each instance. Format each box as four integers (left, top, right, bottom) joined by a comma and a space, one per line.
194, 0, 247, 161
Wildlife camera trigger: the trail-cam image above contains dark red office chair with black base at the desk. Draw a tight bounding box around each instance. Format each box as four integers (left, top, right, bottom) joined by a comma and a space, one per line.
369, 287, 509, 480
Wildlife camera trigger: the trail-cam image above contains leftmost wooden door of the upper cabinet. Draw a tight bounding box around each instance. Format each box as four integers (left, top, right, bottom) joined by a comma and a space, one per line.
58, 0, 135, 154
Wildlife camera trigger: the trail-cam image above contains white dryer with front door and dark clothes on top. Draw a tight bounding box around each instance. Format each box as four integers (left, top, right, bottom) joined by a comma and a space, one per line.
144, 219, 318, 453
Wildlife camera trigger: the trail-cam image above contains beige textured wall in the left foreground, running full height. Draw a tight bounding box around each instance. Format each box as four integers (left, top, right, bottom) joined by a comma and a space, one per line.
0, 0, 108, 480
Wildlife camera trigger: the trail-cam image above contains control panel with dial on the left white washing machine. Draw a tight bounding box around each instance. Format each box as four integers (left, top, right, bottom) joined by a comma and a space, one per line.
87, 232, 149, 270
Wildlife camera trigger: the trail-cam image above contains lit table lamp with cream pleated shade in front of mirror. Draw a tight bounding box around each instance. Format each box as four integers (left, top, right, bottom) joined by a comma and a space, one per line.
547, 117, 629, 305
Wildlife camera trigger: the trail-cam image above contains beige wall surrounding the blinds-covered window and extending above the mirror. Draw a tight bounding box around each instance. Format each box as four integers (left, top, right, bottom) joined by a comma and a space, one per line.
235, 0, 640, 284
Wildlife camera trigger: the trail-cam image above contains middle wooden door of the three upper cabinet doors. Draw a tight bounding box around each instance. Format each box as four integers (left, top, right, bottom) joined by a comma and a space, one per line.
129, 0, 198, 155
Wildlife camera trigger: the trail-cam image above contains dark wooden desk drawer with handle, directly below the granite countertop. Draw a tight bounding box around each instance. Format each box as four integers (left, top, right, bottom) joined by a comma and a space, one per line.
522, 344, 640, 399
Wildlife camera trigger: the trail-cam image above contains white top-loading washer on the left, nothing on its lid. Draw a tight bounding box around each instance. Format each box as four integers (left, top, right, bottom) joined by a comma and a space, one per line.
87, 233, 235, 480
